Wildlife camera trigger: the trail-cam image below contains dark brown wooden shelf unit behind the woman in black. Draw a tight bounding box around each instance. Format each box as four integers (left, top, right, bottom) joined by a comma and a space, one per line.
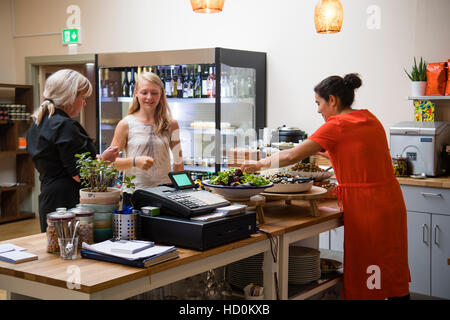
0, 83, 35, 224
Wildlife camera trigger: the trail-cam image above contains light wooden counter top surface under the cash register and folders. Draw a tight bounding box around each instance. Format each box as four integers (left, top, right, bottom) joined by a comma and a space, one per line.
0, 200, 342, 294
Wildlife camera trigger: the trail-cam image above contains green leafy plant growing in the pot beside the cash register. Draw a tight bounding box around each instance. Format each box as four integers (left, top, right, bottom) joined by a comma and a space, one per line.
75, 152, 136, 192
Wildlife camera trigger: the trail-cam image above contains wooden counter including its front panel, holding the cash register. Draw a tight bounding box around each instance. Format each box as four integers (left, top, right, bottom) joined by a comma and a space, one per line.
0, 200, 342, 299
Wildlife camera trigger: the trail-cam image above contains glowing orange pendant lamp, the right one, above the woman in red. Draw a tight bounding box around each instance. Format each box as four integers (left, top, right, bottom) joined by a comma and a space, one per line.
314, 0, 344, 33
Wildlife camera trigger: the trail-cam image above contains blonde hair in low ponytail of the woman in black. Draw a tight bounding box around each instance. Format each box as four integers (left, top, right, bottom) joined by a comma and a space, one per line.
33, 69, 92, 125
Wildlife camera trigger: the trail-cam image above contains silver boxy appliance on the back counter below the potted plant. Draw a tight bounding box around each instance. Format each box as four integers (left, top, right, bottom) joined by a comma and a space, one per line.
390, 121, 450, 176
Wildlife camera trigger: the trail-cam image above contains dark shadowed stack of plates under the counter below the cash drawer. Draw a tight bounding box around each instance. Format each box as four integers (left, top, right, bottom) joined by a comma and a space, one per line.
227, 253, 264, 290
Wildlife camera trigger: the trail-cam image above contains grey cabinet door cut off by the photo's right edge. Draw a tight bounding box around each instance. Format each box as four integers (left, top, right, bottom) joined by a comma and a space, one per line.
431, 214, 450, 299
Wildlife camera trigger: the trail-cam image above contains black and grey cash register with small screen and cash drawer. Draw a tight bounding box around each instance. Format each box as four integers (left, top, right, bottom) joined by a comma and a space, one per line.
132, 171, 256, 251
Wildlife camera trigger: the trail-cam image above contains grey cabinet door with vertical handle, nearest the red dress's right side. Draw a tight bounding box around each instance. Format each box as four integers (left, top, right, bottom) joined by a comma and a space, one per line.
408, 211, 431, 295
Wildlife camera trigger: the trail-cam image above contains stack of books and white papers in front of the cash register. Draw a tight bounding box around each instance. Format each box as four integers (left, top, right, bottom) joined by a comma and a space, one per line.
80, 240, 179, 268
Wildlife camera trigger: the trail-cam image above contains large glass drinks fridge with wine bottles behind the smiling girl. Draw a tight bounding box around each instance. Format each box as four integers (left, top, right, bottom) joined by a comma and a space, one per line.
96, 48, 266, 176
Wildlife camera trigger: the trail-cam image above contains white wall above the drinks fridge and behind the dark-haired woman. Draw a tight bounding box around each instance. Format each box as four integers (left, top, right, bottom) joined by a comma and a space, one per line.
0, 0, 450, 133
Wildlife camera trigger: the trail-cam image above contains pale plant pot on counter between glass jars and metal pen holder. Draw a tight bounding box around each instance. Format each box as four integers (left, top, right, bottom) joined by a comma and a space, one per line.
80, 188, 120, 243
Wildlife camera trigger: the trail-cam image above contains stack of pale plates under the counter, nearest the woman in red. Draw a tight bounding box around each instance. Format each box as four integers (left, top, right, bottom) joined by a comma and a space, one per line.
289, 246, 320, 284
